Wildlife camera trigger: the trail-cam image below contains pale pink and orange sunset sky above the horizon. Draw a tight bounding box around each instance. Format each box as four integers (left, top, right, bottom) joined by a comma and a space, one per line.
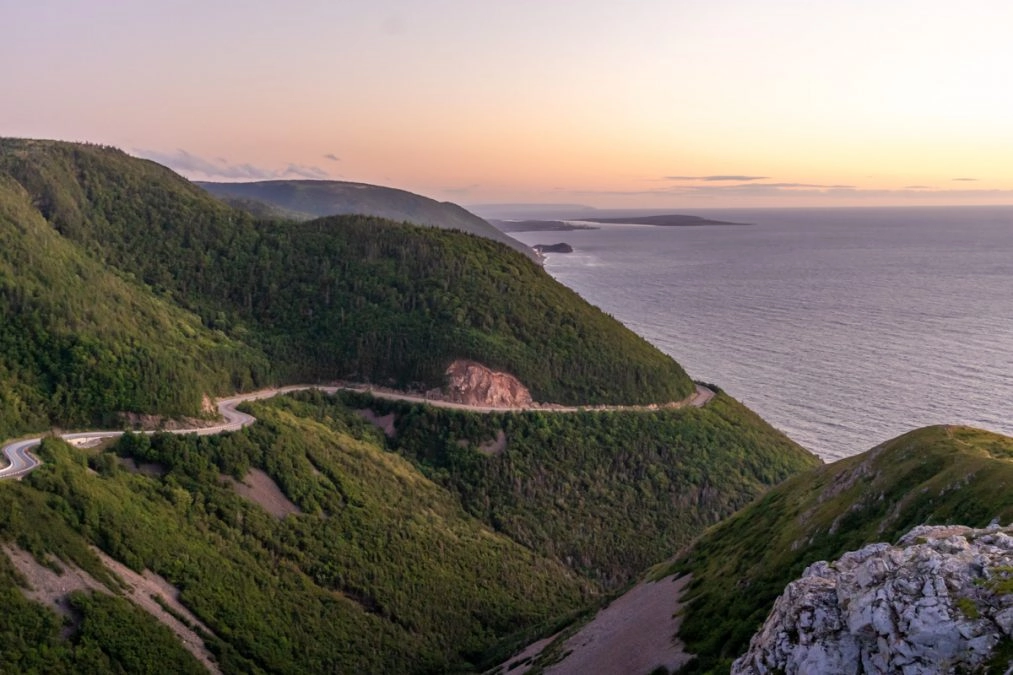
0, 0, 1013, 209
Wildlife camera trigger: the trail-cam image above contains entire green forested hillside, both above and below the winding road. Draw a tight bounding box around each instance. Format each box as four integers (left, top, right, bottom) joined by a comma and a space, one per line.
0, 135, 830, 672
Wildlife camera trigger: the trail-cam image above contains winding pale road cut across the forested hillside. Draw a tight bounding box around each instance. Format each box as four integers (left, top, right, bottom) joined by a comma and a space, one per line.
0, 384, 714, 479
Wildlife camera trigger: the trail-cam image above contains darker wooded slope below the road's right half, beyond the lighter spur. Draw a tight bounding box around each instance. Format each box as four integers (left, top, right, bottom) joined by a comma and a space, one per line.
326, 392, 819, 589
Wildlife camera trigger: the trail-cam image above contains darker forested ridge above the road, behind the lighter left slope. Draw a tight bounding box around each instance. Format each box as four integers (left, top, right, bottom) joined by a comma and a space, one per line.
0, 134, 693, 403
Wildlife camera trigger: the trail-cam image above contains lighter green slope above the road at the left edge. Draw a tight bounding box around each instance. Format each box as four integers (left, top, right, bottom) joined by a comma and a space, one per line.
0, 175, 266, 438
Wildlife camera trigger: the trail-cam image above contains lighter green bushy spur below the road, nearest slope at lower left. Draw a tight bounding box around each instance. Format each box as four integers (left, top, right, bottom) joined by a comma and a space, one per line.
0, 400, 593, 673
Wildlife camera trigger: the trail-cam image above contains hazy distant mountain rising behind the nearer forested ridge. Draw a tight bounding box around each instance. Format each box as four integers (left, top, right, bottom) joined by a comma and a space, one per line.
197, 180, 535, 257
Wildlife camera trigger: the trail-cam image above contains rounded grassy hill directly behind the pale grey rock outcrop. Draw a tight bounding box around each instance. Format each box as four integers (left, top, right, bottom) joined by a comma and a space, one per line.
676, 427, 1013, 672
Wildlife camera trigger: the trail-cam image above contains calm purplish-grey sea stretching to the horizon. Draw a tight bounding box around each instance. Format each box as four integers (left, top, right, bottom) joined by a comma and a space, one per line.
515, 202, 1013, 460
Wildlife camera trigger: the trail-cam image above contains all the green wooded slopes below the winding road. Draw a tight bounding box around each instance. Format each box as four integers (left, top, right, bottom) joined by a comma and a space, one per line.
0, 392, 815, 673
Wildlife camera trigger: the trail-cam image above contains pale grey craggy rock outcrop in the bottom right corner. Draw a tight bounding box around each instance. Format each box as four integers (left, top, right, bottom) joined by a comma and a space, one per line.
731, 526, 1013, 675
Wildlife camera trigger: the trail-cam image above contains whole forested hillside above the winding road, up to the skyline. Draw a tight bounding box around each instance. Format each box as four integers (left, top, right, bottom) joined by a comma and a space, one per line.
0, 139, 692, 433
